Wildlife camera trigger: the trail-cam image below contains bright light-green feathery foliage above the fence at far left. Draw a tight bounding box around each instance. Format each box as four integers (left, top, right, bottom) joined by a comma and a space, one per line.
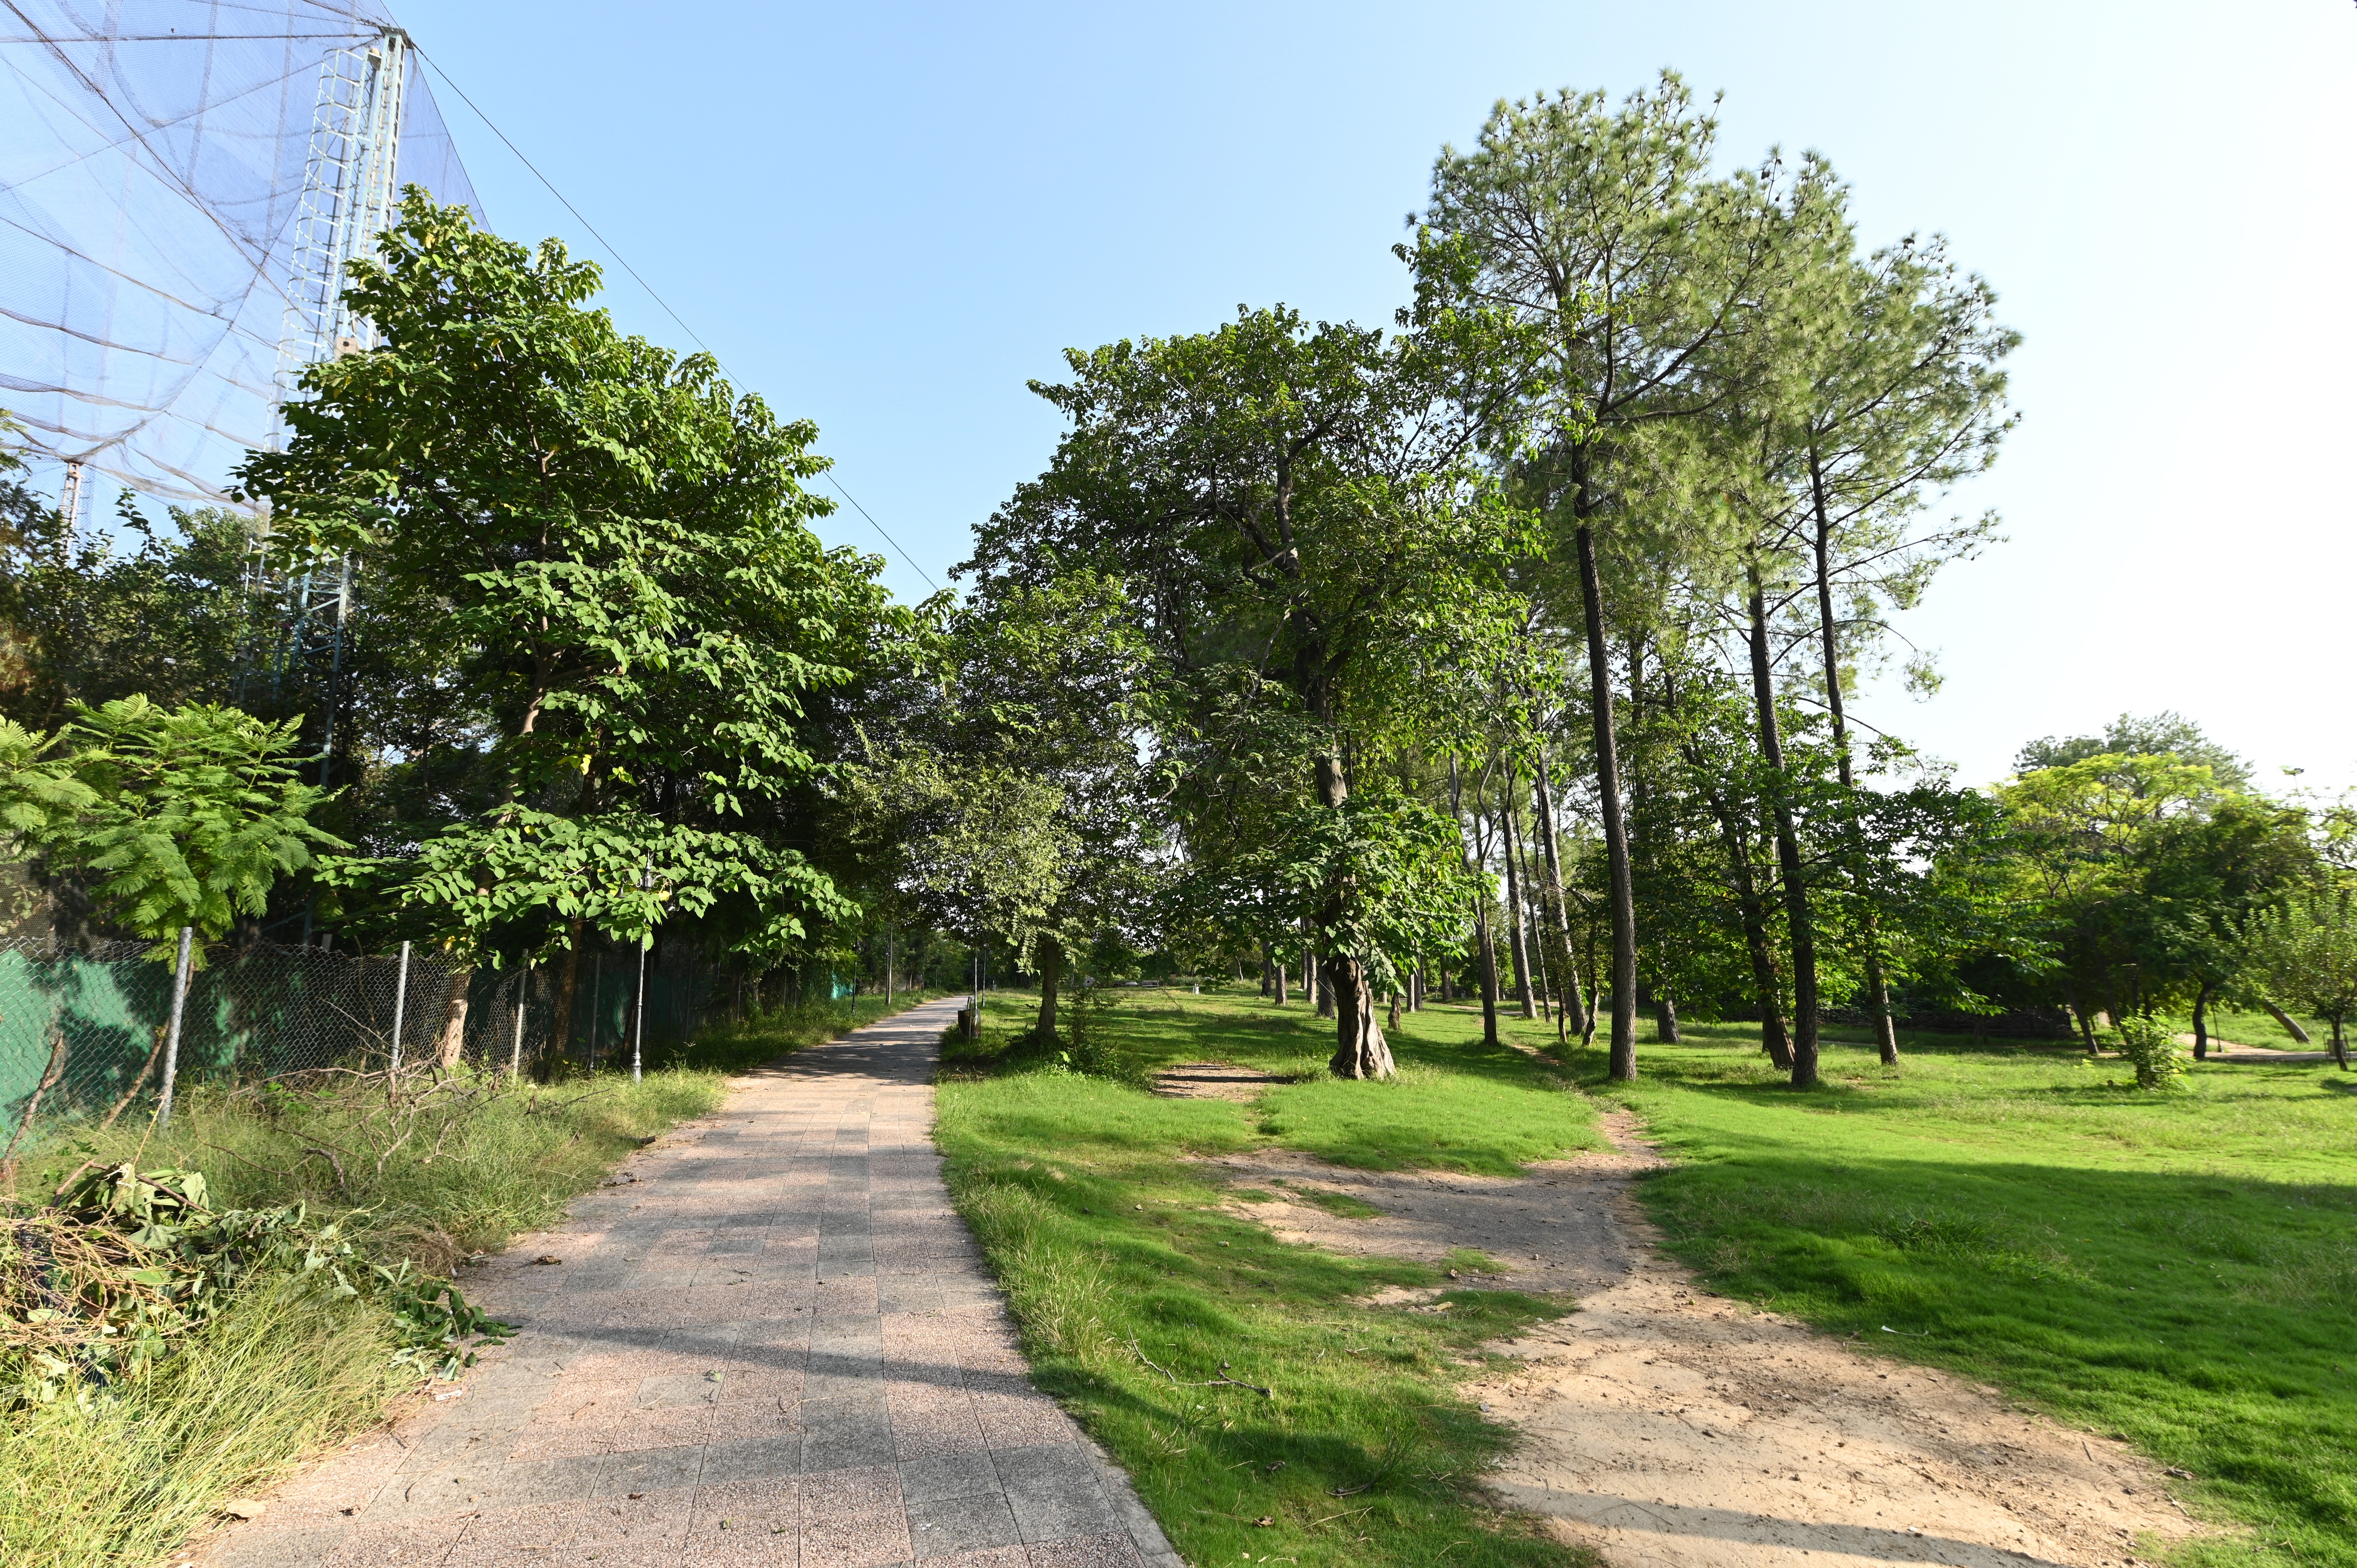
0, 696, 342, 943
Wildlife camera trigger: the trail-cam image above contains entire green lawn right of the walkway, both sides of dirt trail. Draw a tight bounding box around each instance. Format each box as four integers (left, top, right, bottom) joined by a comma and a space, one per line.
940, 988, 2357, 1568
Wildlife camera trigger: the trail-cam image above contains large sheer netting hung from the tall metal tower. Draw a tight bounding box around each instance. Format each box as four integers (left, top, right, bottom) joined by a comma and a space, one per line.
0, 0, 474, 500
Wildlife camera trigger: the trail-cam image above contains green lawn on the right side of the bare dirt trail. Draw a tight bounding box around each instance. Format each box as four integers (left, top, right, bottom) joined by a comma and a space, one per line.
1570, 1021, 2357, 1568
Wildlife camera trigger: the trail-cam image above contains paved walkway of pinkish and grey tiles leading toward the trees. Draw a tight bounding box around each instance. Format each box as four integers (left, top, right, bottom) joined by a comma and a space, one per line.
205, 1002, 1183, 1568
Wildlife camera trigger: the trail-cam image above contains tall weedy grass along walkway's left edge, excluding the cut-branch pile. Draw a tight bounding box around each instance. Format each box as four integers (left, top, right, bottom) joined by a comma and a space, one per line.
0, 998, 915, 1568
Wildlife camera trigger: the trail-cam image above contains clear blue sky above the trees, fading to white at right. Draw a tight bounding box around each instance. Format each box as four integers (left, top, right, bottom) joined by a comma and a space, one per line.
394, 0, 2357, 785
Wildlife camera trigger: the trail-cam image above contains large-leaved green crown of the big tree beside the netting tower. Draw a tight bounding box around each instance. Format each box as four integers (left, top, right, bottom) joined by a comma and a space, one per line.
240, 189, 896, 955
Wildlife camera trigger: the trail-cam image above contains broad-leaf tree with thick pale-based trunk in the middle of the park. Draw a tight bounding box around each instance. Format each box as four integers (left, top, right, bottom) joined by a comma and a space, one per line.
962, 309, 1520, 1077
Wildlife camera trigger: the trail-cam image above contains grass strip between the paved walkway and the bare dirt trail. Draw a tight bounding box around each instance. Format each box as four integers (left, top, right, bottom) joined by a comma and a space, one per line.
938, 993, 1595, 1568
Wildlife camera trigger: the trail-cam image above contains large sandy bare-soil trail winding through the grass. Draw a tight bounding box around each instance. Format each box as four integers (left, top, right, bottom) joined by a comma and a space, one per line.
1216, 1113, 2194, 1568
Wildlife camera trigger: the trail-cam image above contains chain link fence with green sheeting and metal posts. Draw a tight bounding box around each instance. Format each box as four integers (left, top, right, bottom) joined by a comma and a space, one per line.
0, 938, 731, 1146
